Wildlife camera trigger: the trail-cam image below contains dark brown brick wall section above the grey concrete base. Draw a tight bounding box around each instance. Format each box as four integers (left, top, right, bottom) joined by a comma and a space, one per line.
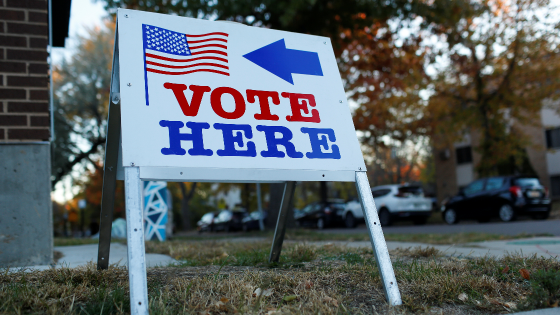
0, 0, 50, 142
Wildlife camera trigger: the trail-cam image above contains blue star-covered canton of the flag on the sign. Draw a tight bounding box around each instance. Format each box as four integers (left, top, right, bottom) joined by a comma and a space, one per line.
142, 24, 191, 56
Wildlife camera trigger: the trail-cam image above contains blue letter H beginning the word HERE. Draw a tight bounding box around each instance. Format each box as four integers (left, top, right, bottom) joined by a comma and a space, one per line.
159, 120, 212, 156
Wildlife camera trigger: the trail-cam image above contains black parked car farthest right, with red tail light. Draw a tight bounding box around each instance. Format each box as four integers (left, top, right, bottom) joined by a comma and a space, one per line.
441, 176, 551, 224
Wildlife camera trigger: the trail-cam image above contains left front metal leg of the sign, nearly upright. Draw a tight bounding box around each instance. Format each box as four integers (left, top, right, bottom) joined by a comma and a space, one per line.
124, 167, 148, 315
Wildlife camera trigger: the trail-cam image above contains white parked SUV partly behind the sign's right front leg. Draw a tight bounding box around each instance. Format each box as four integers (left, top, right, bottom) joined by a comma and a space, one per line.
343, 184, 432, 228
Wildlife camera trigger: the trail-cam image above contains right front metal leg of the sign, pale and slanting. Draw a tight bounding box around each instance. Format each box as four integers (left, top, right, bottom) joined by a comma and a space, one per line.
356, 172, 402, 305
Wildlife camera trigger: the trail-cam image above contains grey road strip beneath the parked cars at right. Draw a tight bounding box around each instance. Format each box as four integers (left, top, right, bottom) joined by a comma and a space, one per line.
323, 220, 560, 236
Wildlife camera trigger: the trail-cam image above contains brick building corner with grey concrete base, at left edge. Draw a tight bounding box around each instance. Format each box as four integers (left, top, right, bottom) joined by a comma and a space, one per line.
0, 0, 70, 266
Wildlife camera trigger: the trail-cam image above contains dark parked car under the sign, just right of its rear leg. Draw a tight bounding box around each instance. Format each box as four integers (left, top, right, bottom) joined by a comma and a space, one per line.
294, 199, 344, 229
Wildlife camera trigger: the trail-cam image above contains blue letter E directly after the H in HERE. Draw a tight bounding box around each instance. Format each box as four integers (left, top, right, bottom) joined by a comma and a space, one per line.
214, 124, 257, 157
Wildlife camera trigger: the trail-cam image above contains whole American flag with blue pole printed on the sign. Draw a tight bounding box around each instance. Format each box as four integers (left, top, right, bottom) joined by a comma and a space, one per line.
142, 24, 229, 105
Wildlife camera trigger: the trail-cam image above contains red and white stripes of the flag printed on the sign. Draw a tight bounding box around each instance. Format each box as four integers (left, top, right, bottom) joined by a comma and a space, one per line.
146, 32, 229, 76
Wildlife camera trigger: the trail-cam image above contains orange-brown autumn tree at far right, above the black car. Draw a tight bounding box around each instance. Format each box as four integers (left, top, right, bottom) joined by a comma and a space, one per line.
429, 0, 560, 176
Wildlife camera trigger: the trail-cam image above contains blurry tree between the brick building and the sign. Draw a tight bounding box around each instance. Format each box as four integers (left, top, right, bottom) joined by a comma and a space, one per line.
52, 23, 114, 187
